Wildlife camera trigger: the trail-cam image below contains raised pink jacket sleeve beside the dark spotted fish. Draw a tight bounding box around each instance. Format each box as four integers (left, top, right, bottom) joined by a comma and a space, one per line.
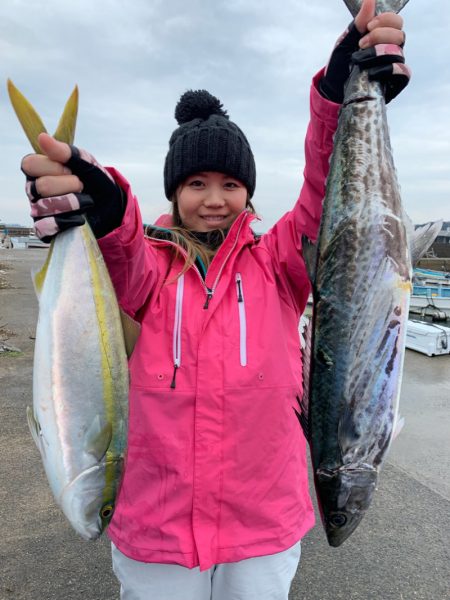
261, 71, 340, 312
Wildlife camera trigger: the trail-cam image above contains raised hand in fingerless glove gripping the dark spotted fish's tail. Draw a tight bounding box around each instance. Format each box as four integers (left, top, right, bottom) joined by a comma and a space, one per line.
319, 0, 411, 104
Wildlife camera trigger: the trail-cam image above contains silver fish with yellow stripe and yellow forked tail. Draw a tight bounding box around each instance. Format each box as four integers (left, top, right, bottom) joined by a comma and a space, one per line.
8, 81, 132, 539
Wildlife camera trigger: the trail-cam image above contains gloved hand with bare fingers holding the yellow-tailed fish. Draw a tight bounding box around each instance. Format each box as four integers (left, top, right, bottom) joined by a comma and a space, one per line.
22, 133, 126, 242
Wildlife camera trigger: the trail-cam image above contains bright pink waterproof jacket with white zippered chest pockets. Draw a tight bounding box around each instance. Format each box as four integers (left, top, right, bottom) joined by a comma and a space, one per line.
100, 74, 339, 569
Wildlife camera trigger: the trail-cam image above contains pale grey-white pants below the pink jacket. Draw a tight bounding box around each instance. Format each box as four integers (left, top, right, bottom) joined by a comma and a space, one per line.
112, 542, 300, 600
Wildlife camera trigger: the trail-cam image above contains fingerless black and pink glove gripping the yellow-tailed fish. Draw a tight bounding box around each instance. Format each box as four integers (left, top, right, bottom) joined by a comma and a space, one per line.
25, 146, 126, 242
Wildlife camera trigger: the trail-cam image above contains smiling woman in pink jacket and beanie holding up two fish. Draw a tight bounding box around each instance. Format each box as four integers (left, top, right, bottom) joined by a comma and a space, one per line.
22, 0, 409, 600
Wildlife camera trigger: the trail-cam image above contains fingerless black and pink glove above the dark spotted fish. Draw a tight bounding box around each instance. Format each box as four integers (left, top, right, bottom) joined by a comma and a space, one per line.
319, 22, 411, 104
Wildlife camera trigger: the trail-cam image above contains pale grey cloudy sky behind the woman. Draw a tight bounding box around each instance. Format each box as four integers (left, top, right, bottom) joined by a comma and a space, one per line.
0, 0, 450, 230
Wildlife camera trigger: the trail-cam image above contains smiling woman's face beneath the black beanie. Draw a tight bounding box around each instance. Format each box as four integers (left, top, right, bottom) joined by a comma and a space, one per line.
176, 171, 247, 232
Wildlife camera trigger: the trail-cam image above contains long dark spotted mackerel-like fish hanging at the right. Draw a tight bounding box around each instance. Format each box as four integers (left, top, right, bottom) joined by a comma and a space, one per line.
300, 0, 411, 546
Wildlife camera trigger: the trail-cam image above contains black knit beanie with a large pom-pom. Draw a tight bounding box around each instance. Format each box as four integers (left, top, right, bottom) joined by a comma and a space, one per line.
164, 90, 256, 199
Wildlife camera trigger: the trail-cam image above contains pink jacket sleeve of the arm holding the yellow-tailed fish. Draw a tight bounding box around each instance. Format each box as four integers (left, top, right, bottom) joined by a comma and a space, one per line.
98, 167, 158, 317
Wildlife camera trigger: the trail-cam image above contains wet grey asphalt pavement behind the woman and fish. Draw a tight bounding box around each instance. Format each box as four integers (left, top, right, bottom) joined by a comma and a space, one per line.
0, 249, 450, 600
